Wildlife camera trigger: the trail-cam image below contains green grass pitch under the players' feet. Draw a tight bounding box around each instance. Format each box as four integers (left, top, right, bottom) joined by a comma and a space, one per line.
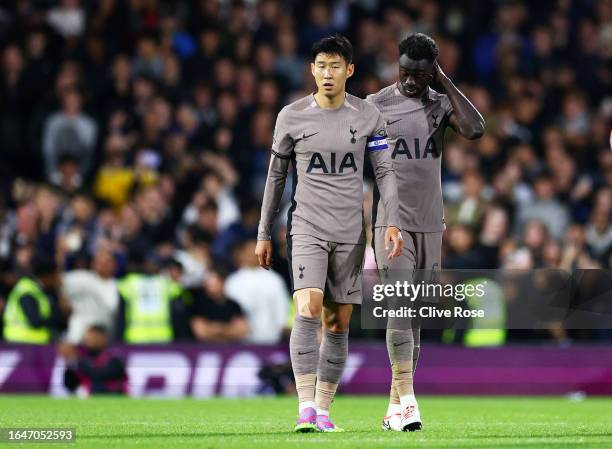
0, 396, 612, 449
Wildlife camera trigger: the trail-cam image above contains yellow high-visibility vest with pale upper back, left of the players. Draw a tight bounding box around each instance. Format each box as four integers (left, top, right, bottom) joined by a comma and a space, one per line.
117, 274, 182, 343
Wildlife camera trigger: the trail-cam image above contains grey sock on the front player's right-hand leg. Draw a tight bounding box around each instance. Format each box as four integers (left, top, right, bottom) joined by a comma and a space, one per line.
315, 329, 348, 413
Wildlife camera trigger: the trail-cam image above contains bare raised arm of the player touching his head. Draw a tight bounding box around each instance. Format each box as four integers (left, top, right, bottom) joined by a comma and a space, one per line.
434, 61, 485, 140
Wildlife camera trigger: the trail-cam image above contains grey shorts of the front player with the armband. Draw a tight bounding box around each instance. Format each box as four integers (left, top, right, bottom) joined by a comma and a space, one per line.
287, 234, 365, 304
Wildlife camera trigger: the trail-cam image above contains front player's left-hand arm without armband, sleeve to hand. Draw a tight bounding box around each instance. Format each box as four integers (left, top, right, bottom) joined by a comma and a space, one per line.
255, 109, 293, 269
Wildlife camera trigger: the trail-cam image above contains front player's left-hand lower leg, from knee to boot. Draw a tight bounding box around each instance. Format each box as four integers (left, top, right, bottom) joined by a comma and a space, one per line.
289, 288, 323, 432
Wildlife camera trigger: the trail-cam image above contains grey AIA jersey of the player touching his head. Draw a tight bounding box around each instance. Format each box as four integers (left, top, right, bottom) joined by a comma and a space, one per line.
366, 84, 453, 232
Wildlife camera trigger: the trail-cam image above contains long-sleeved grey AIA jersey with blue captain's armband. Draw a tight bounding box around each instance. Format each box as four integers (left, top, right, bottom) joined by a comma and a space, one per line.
258, 94, 399, 244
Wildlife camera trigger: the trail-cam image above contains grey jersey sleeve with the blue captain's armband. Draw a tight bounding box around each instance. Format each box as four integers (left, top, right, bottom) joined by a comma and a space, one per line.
366, 110, 400, 228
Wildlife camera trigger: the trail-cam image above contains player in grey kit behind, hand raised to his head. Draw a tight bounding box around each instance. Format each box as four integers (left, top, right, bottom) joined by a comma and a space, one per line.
367, 33, 485, 431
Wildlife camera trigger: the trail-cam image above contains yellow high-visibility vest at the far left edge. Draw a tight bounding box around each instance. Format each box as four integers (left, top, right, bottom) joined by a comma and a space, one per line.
4, 277, 51, 345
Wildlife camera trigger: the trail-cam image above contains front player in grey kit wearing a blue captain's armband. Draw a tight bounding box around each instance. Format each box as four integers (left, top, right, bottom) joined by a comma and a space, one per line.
255, 36, 403, 432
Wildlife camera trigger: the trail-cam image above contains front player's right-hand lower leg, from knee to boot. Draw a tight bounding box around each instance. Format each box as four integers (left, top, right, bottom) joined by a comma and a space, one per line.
315, 303, 353, 432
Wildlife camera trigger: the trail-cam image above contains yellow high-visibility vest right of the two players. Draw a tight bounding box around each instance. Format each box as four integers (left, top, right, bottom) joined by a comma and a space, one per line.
463, 278, 507, 347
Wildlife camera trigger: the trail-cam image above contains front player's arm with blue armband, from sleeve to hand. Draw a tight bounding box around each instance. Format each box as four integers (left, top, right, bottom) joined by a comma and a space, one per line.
366, 117, 404, 259
